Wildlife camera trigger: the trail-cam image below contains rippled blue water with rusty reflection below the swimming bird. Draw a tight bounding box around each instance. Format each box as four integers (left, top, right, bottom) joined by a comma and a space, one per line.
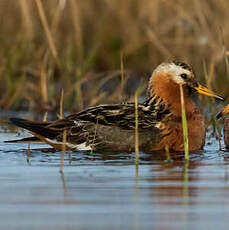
0, 128, 229, 230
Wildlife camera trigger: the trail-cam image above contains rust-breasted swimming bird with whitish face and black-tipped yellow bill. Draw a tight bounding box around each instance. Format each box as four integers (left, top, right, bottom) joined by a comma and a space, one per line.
6, 61, 223, 152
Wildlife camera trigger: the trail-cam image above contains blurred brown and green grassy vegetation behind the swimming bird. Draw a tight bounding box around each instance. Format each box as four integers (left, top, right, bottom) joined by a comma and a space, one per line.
0, 0, 229, 113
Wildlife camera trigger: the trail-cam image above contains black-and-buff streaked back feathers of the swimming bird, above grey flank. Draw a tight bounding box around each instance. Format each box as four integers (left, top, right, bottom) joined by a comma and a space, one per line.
66, 97, 170, 130
